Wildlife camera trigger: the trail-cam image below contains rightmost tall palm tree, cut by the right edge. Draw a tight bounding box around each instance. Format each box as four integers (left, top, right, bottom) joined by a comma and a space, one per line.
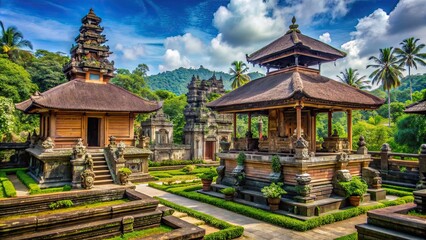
395, 37, 426, 101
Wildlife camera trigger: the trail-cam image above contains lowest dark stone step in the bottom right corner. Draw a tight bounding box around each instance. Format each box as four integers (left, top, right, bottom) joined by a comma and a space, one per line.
355, 224, 424, 240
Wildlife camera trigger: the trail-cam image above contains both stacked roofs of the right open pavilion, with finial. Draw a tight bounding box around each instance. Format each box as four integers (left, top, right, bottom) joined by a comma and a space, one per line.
207, 18, 384, 112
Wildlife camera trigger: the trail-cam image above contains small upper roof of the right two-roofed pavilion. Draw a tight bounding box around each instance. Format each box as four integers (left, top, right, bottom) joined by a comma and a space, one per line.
247, 32, 346, 62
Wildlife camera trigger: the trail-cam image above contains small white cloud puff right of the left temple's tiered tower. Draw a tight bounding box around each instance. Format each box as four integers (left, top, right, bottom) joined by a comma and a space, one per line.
164, 33, 204, 54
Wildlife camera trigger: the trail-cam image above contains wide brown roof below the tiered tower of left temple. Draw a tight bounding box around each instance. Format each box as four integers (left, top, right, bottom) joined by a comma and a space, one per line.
16, 79, 161, 113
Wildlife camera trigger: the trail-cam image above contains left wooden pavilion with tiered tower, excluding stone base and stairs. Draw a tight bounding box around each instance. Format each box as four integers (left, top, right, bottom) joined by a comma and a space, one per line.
16, 9, 161, 148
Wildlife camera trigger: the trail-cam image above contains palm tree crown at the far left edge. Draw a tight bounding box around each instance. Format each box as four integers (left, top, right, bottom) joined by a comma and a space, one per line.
0, 21, 33, 60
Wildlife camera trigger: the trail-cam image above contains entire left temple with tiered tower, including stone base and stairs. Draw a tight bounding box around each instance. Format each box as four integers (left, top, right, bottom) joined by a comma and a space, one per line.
16, 9, 161, 187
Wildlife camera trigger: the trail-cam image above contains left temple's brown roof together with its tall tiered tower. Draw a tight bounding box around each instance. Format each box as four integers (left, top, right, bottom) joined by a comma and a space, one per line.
16, 9, 161, 113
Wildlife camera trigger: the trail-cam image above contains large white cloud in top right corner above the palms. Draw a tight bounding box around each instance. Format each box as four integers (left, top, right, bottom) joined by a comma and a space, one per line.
323, 0, 426, 78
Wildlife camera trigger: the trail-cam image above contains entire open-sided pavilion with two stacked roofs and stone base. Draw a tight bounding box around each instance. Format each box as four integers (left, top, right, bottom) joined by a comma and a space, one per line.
207, 18, 384, 216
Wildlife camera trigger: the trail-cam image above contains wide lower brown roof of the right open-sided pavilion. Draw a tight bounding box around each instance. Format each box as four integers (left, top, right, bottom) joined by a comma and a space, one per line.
207, 68, 384, 111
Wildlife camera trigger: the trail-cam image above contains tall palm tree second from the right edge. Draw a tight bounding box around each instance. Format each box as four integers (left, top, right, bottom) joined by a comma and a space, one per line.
367, 47, 404, 126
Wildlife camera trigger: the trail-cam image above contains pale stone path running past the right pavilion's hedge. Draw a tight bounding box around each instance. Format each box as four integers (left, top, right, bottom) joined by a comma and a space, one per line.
136, 184, 367, 240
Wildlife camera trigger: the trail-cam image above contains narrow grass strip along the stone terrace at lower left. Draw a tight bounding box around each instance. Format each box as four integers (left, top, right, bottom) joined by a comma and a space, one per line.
0, 199, 130, 222
